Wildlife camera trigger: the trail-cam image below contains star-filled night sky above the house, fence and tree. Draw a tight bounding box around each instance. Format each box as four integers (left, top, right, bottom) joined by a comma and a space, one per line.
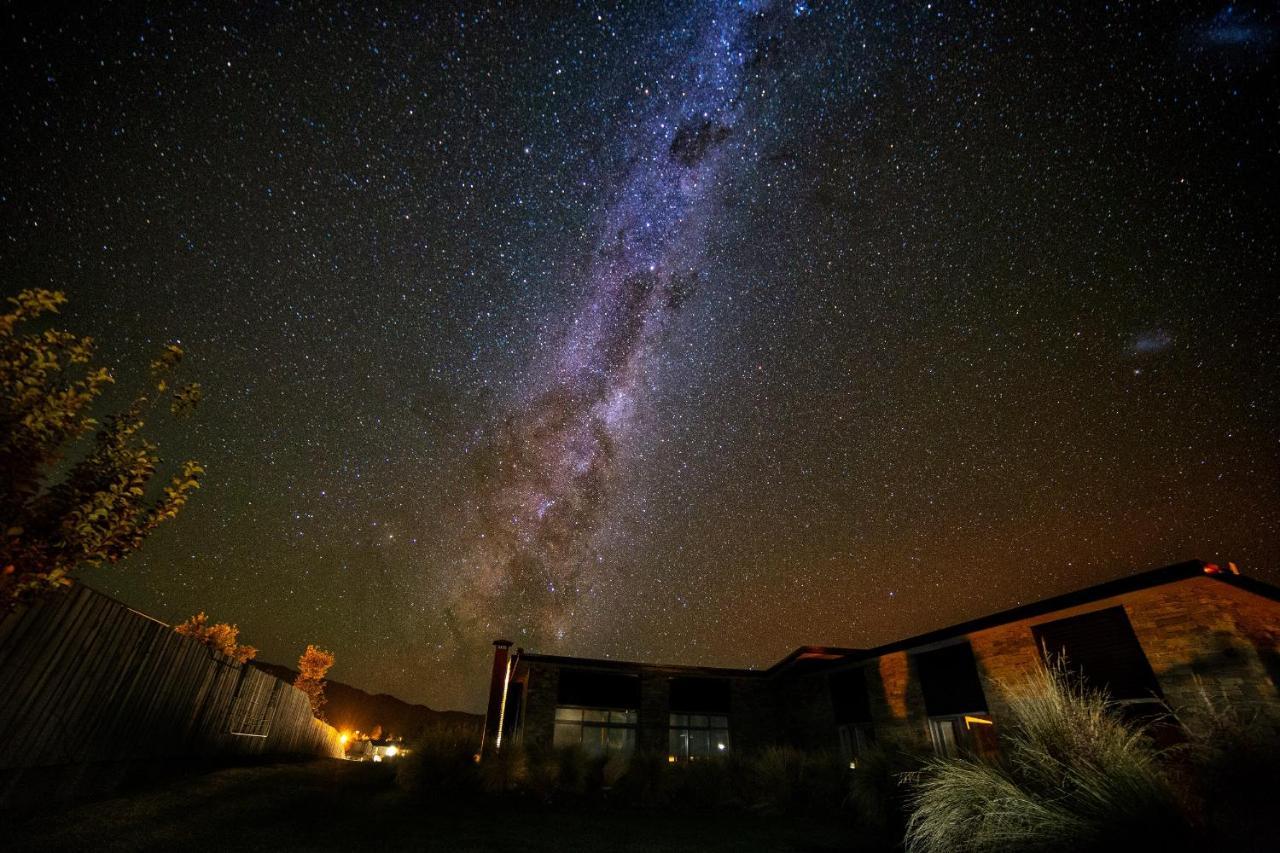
0, 0, 1280, 710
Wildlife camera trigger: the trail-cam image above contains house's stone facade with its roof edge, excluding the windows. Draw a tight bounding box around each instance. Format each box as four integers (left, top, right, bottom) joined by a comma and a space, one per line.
488, 564, 1280, 752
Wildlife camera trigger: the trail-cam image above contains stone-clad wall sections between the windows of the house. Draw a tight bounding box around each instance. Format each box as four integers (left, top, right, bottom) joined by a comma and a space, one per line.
509, 576, 1280, 752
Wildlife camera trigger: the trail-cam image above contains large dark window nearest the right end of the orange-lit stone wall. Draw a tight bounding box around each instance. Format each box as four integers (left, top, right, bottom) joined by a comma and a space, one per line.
1032, 607, 1160, 701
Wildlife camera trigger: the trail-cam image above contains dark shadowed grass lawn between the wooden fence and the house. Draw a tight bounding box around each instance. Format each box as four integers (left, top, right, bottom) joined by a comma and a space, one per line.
0, 760, 854, 853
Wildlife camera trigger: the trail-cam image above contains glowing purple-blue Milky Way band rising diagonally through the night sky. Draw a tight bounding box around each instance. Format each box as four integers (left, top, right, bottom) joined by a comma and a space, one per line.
451, 3, 783, 648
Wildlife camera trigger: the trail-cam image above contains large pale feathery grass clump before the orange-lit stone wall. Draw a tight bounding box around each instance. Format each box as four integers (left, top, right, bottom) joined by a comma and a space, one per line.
906, 663, 1193, 853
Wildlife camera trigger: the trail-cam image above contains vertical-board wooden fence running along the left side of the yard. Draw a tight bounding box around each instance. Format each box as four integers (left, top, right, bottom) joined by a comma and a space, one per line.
0, 585, 342, 807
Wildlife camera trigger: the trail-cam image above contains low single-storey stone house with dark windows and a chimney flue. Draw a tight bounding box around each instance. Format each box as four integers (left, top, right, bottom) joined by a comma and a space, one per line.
485, 561, 1280, 761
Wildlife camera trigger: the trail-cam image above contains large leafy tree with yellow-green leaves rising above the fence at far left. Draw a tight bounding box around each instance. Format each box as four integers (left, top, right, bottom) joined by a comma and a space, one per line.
0, 289, 204, 615
